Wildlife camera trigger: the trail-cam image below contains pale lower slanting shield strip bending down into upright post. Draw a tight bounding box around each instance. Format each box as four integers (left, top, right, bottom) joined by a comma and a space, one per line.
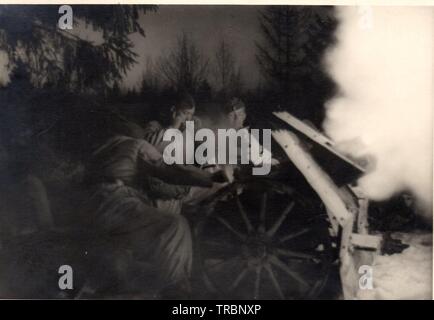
272, 130, 378, 299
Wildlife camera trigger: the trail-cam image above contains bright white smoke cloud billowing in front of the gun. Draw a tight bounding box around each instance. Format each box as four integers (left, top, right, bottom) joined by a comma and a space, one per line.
324, 7, 434, 216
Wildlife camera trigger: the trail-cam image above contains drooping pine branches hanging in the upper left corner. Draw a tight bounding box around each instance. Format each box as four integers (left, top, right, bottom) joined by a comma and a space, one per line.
0, 5, 156, 92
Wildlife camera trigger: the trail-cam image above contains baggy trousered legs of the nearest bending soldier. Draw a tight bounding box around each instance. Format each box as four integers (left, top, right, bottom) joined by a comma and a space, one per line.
88, 186, 192, 292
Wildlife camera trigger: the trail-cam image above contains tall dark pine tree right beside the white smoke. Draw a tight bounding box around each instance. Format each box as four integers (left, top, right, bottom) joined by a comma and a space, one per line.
257, 6, 337, 124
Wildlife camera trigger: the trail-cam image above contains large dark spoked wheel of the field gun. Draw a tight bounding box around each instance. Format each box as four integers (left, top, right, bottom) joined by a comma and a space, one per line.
196, 182, 334, 299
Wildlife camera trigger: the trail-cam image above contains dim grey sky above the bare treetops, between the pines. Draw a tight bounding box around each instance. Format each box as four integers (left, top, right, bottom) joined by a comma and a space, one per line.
125, 5, 263, 87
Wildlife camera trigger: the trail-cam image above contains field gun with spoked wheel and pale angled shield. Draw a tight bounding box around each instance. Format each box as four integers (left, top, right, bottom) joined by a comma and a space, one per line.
195, 112, 381, 299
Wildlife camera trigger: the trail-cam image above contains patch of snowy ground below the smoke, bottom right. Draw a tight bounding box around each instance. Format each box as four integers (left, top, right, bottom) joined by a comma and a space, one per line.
358, 232, 433, 300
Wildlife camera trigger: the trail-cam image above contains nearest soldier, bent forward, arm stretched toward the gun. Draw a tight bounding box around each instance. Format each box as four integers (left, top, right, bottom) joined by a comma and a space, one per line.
82, 132, 229, 296
